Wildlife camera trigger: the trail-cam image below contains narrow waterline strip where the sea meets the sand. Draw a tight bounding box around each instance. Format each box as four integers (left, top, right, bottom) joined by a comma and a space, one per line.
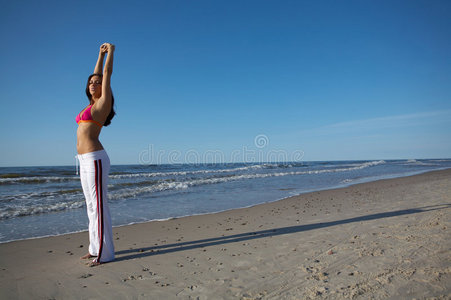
0, 167, 451, 245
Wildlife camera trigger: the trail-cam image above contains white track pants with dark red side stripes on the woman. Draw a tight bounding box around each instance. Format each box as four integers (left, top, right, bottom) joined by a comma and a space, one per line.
78, 150, 114, 262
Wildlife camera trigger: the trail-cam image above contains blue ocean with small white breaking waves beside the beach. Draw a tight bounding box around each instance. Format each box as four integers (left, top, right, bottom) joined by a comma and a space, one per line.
0, 159, 451, 243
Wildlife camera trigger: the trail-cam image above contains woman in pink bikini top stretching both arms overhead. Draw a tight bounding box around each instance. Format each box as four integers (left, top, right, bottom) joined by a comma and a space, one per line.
75, 43, 115, 266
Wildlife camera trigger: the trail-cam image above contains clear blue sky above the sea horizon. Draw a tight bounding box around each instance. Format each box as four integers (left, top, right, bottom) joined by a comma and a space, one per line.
0, 0, 451, 166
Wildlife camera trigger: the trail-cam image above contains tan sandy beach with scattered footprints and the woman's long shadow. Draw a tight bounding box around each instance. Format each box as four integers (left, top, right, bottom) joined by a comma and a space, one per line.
0, 169, 451, 299
